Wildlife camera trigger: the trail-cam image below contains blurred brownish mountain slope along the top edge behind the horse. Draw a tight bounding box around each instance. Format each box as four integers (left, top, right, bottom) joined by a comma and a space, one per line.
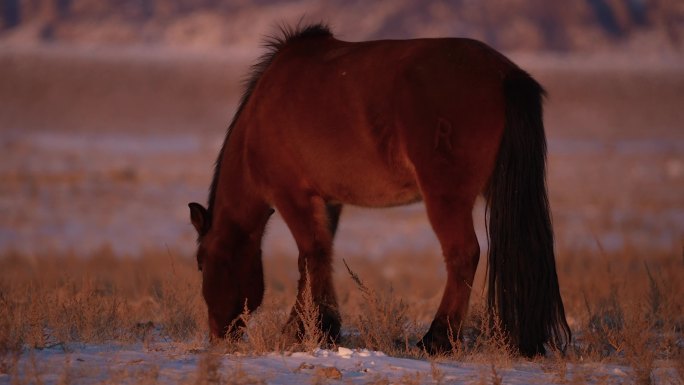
0, 0, 684, 52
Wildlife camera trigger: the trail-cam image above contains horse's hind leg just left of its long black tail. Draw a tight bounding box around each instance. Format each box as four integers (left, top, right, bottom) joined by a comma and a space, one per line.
419, 174, 480, 353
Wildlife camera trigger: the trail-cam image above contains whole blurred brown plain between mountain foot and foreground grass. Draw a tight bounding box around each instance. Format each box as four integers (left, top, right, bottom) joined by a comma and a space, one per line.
0, 46, 684, 256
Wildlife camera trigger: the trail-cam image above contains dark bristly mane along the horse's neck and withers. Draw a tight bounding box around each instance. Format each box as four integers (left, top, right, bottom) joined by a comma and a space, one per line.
207, 23, 333, 215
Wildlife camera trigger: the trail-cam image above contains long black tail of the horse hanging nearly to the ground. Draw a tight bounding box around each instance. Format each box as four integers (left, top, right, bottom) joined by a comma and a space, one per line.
486, 69, 571, 356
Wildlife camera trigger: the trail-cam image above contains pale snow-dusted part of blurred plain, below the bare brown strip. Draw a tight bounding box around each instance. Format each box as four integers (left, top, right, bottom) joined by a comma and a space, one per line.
0, 130, 684, 258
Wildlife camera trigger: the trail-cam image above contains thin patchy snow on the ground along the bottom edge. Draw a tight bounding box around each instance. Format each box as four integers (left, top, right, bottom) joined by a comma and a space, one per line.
0, 343, 677, 385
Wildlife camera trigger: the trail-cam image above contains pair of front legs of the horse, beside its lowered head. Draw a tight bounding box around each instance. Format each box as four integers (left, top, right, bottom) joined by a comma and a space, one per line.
276, 194, 342, 340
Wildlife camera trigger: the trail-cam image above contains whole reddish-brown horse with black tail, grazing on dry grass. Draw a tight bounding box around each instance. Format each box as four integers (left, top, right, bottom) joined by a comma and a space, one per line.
189, 25, 570, 356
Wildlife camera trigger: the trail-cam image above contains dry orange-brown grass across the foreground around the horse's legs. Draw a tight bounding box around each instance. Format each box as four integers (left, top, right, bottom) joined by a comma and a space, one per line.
0, 244, 684, 384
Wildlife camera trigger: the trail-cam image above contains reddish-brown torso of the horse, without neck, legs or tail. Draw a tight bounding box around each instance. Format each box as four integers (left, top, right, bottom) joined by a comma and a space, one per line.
241, 38, 512, 206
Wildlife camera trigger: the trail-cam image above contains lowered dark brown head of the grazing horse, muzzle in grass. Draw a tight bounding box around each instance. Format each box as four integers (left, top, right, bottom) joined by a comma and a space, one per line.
188, 202, 266, 338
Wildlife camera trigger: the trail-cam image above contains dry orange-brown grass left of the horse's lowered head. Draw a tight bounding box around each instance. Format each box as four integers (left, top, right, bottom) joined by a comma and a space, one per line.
0, 249, 206, 355
